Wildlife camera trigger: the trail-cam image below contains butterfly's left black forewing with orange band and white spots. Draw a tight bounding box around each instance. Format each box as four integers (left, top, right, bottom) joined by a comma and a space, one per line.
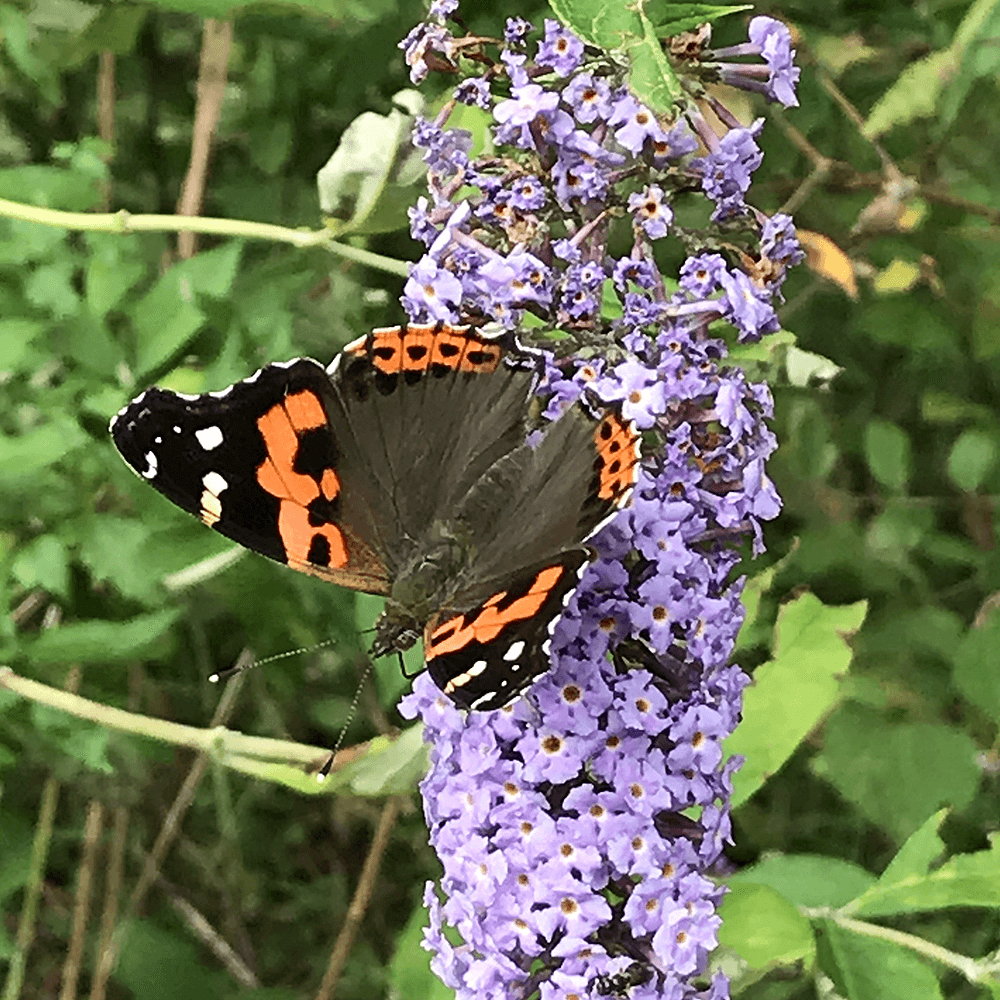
111, 358, 391, 594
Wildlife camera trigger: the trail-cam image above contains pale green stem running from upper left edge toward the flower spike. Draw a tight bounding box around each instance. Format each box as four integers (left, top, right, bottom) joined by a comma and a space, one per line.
0, 198, 409, 278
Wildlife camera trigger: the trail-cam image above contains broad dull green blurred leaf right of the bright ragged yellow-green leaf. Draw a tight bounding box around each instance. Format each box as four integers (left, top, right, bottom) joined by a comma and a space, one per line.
813, 703, 980, 839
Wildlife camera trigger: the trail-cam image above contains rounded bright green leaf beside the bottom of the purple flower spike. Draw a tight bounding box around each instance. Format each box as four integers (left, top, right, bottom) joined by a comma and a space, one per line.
719, 882, 813, 969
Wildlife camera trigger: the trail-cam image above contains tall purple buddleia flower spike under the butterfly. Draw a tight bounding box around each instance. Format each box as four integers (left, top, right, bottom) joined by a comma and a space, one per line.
401, 7, 802, 1000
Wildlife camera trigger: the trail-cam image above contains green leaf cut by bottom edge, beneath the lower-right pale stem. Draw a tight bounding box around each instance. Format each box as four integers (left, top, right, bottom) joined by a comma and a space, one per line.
816, 920, 941, 1000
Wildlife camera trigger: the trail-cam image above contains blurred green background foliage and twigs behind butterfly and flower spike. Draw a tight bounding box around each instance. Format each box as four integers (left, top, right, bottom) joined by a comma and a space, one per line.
0, 0, 1000, 1000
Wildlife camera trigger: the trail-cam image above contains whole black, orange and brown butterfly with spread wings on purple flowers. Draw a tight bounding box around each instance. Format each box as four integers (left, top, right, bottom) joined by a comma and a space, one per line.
111, 323, 639, 709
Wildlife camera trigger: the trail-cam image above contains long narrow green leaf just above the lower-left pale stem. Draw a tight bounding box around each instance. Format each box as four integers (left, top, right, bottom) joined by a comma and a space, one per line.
25, 608, 184, 663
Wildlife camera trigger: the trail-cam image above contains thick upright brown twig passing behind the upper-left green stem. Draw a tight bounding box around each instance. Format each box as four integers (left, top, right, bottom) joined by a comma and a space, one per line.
177, 17, 233, 260
